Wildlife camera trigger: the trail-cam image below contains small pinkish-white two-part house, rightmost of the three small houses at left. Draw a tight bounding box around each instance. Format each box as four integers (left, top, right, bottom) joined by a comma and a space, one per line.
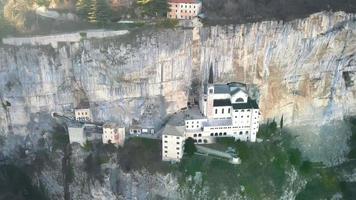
103, 123, 125, 146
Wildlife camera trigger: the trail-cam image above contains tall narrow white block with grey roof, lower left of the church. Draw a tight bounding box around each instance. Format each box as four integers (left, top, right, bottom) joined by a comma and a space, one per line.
162, 125, 186, 161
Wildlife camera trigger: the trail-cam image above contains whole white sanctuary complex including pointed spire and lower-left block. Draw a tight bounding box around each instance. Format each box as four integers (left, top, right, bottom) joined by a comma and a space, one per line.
162, 66, 261, 161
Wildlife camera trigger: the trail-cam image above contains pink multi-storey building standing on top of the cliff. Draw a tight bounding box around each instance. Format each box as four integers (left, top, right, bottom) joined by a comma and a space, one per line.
167, 0, 202, 19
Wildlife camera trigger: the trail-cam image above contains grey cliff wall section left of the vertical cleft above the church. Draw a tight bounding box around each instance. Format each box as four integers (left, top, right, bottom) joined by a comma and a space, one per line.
0, 30, 192, 134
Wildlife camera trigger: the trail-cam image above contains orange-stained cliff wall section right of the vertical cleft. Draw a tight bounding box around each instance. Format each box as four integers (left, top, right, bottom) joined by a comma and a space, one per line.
201, 13, 356, 125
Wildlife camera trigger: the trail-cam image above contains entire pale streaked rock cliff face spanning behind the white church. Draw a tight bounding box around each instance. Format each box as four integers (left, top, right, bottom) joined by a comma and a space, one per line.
0, 13, 356, 135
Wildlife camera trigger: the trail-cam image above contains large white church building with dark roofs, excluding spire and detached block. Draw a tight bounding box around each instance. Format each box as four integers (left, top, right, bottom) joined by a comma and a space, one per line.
195, 83, 260, 143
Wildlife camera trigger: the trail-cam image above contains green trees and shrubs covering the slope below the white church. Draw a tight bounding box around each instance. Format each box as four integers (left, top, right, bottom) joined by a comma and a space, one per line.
175, 121, 350, 199
